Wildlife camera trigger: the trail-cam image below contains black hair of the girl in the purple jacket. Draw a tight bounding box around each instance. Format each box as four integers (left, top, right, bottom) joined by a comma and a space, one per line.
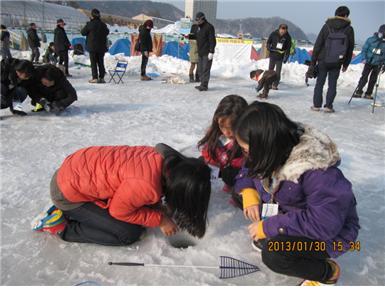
234, 101, 303, 178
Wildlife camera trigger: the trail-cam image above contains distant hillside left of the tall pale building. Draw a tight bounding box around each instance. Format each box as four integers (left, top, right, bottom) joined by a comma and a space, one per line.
62, 1, 184, 21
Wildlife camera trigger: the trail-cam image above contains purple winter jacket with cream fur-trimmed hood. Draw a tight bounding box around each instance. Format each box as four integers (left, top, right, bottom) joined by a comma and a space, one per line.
235, 126, 360, 258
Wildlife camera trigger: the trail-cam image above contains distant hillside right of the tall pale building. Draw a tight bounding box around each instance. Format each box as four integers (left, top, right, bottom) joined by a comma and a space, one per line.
215, 17, 308, 40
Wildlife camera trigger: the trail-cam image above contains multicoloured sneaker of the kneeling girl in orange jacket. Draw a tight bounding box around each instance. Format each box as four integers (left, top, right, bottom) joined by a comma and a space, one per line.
32, 206, 67, 234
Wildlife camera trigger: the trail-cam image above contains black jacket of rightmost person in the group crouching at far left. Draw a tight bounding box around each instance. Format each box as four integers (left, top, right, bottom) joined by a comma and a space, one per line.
36, 64, 78, 108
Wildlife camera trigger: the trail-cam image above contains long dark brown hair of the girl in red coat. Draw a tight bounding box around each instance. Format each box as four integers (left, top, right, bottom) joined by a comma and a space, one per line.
198, 94, 247, 161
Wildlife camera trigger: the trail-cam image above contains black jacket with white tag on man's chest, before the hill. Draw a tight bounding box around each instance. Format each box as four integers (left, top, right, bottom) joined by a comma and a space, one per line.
267, 30, 291, 60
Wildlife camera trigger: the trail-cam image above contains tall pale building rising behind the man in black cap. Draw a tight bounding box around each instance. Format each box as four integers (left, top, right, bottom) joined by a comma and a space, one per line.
184, 0, 217, 24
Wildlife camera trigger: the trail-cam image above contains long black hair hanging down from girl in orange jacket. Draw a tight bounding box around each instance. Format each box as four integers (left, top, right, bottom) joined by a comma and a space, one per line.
162, 155, 211, 238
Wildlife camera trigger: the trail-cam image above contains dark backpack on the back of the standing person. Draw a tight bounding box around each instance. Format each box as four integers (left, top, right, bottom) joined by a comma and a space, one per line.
324, 25, 349, 64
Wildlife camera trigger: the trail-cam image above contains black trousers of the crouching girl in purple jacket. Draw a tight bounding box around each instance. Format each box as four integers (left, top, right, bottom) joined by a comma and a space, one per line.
262, 235, 333, 282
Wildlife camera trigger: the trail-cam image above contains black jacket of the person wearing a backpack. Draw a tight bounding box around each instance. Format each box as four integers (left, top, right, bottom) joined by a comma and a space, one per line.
312, 16, 354, 67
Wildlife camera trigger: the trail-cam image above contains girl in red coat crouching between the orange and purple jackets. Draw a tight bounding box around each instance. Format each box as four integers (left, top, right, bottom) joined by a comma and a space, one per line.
198, 95, 247, 191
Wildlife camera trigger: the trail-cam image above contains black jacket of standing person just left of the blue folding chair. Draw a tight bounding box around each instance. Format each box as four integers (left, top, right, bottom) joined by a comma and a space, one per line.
81, 18, 110, 53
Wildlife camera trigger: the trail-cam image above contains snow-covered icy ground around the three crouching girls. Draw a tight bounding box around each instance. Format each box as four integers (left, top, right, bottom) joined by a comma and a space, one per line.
0, 56, 385, 285
